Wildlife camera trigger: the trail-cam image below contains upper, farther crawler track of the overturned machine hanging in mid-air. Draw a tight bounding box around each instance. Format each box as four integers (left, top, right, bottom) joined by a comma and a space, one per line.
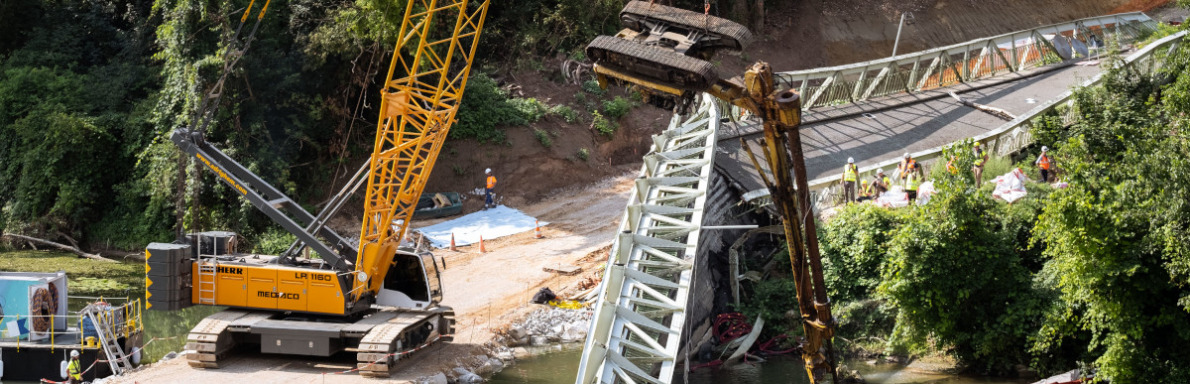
620, 0, 752, 52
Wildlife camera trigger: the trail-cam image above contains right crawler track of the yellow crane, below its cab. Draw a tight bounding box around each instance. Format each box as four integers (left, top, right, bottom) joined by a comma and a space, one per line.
356, 308, 455, 378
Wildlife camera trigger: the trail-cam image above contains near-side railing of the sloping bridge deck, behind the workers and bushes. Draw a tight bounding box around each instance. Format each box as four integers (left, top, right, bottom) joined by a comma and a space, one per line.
804, 31, 1188, 209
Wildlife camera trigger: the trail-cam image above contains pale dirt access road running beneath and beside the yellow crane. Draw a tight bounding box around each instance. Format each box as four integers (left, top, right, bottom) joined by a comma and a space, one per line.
118, 174, 637, 384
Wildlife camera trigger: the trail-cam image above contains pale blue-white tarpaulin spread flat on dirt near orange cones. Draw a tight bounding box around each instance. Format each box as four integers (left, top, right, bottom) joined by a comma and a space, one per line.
414, 206, 549, 248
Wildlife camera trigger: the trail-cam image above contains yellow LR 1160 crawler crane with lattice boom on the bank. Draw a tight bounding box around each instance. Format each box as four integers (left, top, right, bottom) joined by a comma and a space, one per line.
145, 0, 489, 377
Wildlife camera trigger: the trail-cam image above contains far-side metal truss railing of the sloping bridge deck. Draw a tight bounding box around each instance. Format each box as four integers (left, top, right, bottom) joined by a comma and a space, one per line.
777, 12, 1157, 111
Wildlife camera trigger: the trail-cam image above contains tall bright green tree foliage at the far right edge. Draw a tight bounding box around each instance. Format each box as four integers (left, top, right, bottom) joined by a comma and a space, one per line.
1036, 45, 1190, 383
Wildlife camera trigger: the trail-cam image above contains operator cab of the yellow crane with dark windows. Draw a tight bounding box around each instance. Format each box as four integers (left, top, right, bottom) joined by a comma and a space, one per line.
376, 247, 443, 309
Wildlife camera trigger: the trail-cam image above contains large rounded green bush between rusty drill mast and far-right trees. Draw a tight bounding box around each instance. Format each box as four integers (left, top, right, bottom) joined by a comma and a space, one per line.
877, 185, 1051, 372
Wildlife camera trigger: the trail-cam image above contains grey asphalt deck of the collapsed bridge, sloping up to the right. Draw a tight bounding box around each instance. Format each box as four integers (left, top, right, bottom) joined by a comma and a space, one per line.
715, 61, 1100, 197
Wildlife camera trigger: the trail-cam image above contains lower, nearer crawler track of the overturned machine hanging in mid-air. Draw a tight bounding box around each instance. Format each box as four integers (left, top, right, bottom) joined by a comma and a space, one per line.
587, 36, 719, 90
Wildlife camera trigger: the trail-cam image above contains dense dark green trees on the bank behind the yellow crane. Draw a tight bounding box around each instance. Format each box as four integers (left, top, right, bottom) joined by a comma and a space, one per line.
0, 0, 675, 248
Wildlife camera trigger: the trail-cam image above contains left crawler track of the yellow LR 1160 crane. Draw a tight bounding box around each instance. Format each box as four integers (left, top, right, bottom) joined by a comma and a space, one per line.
186, 309, 273, 369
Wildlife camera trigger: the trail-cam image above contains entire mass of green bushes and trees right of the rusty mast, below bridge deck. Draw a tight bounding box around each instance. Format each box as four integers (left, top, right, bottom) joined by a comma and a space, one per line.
820, 37, 1190, 383
